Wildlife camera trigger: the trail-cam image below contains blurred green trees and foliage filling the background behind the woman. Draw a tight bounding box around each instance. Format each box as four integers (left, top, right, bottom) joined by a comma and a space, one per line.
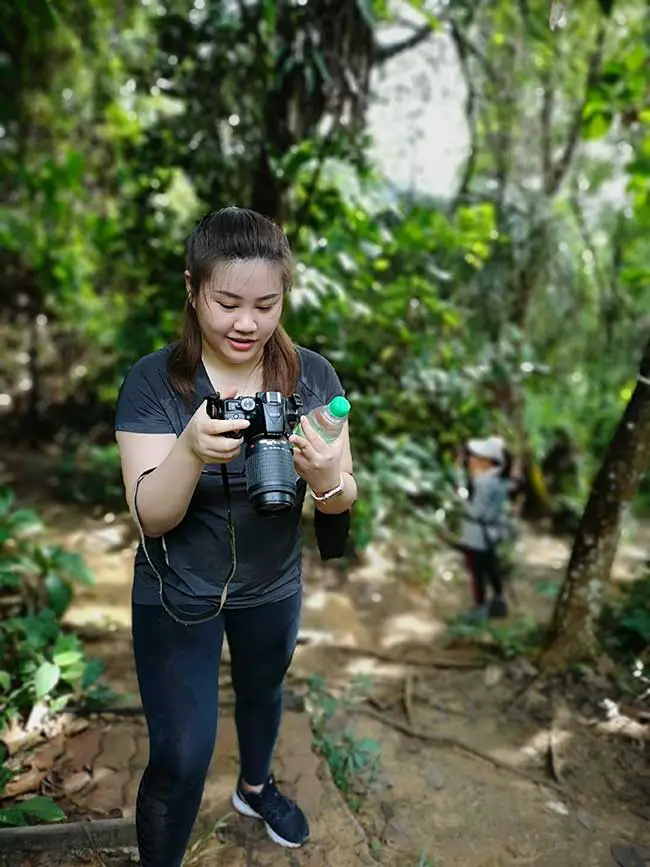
0, 0, 649, 547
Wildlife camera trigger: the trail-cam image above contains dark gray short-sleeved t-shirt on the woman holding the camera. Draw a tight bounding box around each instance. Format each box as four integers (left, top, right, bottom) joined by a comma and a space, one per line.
115, 346, 344, 609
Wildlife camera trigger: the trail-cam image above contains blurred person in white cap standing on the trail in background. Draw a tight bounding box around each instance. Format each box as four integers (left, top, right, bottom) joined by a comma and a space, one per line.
460, 436, 511, 620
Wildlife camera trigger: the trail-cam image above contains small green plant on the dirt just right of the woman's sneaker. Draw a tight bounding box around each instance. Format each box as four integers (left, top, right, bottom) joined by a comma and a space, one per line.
308, 676, 381, 810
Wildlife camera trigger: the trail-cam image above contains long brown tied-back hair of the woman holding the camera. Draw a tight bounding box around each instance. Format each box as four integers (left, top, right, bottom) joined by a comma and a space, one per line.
167, 208, 300, 403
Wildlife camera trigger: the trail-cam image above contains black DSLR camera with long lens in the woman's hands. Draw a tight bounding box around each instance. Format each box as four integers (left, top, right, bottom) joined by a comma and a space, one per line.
207, 391, 302, 515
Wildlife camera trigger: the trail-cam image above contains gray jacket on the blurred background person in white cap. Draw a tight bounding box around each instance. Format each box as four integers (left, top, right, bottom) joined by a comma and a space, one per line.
460, 469, 508, 551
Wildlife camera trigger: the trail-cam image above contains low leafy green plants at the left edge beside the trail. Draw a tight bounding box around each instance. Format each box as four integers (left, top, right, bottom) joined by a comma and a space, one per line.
0, 488, 109, 825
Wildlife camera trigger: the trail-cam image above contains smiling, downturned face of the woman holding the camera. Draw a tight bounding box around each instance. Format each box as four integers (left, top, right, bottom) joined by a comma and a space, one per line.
190, 259, 283, 365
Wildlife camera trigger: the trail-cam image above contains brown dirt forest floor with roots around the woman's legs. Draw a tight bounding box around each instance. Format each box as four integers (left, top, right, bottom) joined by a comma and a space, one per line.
0, 454, 650, 867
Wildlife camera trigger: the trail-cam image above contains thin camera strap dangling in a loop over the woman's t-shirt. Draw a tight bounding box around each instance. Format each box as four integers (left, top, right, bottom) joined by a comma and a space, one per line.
132, 464, 237, 626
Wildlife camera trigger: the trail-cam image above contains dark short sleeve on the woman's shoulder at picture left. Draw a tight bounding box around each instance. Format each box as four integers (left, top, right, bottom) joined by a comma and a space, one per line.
115, 361, 175, 433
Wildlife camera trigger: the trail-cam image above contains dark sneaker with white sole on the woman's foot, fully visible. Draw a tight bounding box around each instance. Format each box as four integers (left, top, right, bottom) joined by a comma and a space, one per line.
232, 775, 309, 849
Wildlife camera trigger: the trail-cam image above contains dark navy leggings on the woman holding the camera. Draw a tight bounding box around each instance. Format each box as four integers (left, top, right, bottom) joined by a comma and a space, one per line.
133, 592, 301, 867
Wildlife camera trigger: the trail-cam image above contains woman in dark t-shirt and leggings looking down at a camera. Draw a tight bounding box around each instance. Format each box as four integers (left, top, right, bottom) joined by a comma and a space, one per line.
115, 208, 357, 867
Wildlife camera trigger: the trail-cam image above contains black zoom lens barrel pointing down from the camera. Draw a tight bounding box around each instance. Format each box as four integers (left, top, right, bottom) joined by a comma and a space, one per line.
246, 437, 296, 515
